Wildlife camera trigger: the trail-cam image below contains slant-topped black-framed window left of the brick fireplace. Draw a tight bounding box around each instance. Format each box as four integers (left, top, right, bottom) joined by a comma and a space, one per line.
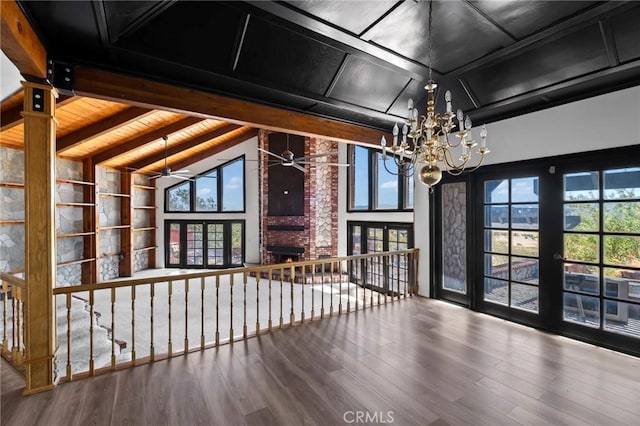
165, 157, 245, 213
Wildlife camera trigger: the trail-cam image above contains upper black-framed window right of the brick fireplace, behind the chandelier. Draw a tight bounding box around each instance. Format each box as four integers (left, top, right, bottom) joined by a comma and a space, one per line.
348, 145, 413, 211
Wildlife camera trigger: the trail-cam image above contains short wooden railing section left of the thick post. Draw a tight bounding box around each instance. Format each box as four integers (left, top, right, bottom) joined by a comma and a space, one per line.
0, 272, 25, 371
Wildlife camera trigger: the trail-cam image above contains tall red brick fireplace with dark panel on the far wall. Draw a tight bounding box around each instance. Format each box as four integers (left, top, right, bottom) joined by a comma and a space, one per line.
259, 130, 338, 264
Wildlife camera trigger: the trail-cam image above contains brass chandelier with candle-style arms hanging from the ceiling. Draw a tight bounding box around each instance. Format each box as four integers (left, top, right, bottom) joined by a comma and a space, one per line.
380, 0, 489, 191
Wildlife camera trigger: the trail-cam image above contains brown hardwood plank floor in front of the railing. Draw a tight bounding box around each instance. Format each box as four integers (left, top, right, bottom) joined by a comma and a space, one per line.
0, 298, 640, 426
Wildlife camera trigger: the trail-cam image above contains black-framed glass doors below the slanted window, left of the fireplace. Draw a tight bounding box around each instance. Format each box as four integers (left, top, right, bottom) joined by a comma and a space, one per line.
165, 220, 244, 268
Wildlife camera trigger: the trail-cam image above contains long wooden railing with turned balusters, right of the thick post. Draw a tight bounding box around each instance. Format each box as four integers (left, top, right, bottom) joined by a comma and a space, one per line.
12, 249, 418, 382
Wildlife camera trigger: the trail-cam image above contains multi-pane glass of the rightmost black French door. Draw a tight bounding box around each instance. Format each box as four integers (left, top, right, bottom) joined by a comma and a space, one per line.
563, 167, 640, 337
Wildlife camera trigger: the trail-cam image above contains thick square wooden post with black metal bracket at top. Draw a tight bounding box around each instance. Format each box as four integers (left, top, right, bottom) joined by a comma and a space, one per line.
22, 82, 58, 395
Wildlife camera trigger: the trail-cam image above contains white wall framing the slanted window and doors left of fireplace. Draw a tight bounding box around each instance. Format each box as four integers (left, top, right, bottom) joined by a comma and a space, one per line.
156, 137, 260, 268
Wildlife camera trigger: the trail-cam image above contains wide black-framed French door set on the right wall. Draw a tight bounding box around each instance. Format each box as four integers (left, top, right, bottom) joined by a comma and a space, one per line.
431, 147, 640, 355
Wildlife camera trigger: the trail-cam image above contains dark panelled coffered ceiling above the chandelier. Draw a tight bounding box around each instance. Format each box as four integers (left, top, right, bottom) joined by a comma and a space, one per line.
20, 0, 640, 130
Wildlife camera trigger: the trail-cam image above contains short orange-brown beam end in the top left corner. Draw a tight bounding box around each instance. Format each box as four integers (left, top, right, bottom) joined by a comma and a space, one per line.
0, 0, 47, 79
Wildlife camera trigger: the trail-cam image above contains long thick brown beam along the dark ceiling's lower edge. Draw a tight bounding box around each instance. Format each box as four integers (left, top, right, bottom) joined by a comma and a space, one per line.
73, 66, 392, 147
